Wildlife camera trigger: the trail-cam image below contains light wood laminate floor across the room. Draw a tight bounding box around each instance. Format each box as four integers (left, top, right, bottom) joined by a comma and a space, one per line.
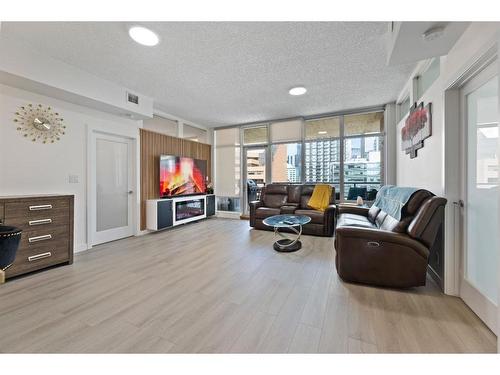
0, 219, 496, 353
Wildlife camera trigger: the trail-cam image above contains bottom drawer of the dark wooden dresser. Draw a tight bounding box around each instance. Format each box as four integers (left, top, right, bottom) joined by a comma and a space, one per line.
5, 244, 70, 277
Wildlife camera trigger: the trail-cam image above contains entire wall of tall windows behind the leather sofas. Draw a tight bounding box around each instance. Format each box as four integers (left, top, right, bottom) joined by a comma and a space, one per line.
214, 110, 384, 212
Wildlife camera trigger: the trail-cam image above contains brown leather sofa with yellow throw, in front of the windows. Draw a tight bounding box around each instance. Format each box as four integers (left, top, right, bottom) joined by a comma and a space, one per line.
250, 184, 335, 237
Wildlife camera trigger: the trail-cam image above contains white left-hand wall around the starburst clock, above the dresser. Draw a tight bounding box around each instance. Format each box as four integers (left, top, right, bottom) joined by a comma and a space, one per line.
0, 85, 142, 251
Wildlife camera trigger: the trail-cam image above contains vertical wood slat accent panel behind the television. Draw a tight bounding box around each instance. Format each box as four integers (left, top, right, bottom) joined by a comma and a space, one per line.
140, 129, 212, 230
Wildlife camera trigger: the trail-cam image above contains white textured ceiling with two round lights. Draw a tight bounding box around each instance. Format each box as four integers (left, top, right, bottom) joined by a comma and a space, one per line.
2, 22, 414, 126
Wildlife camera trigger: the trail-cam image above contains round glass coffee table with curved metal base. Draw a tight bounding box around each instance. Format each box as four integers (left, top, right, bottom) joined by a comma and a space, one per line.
263, 215, 311, 253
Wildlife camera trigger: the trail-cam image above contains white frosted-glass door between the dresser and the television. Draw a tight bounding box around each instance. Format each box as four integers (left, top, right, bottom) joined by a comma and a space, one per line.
90, 132, 134, 245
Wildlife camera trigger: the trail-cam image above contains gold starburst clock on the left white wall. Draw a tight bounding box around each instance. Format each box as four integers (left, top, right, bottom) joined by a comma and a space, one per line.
14, 104, 66, 143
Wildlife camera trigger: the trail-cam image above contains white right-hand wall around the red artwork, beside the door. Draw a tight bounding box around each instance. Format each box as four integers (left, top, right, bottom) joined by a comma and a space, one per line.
396, 23, 500, 294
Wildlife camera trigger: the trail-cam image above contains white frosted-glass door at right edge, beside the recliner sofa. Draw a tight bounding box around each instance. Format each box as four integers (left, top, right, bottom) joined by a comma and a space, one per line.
460, 63, 500, 333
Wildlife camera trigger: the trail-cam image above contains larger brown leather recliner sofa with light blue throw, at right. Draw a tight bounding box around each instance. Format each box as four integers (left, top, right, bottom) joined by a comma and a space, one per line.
335, 190, 446, 288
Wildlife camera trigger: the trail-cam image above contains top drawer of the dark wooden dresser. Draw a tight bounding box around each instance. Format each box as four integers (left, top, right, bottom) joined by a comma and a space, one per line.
4, 198, 69, 220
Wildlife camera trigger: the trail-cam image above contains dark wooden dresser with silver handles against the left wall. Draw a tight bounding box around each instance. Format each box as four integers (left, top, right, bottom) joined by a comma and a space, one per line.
0, 195, 74, 278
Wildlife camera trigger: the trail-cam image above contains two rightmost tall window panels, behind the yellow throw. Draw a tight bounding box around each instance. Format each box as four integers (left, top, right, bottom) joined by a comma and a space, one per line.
305, 111, 384, 200
